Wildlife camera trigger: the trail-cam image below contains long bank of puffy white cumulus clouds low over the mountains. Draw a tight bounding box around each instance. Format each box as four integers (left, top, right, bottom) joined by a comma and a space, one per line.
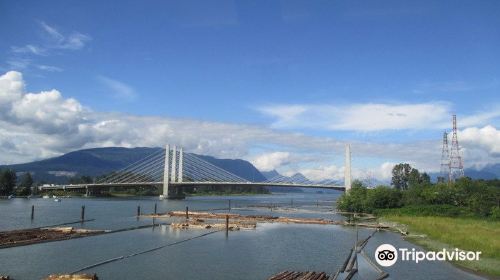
0, 71, 500, 180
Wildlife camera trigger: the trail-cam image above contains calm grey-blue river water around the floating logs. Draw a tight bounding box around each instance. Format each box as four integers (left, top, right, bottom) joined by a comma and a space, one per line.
0, 192, 483, 280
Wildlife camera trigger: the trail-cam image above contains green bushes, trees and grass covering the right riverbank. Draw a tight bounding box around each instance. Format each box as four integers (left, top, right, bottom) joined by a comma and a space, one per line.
337, 164, 500, 279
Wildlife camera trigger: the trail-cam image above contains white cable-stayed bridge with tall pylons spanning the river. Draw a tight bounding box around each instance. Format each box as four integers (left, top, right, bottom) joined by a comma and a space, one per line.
42, 145, 350, 198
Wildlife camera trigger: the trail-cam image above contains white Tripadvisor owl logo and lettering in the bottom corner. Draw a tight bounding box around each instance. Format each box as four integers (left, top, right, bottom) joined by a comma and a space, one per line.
375, 244, 481, 266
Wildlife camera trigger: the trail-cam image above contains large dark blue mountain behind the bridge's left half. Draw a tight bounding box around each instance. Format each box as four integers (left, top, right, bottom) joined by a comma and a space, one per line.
0, 147, 266, 183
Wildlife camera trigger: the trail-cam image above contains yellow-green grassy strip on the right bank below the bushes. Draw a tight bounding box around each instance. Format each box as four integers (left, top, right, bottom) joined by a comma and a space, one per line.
381, 211, 500, 279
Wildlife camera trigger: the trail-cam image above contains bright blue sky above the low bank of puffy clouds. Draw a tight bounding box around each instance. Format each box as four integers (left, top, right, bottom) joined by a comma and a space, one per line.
0, 1, 500, 182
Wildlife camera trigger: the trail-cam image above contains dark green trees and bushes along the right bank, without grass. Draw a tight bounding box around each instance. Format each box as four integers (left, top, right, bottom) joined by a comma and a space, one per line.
337, 163, 500, 219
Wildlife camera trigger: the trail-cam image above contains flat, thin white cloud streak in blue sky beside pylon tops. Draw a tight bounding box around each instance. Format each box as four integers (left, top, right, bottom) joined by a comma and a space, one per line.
258, 102, 500, 132
